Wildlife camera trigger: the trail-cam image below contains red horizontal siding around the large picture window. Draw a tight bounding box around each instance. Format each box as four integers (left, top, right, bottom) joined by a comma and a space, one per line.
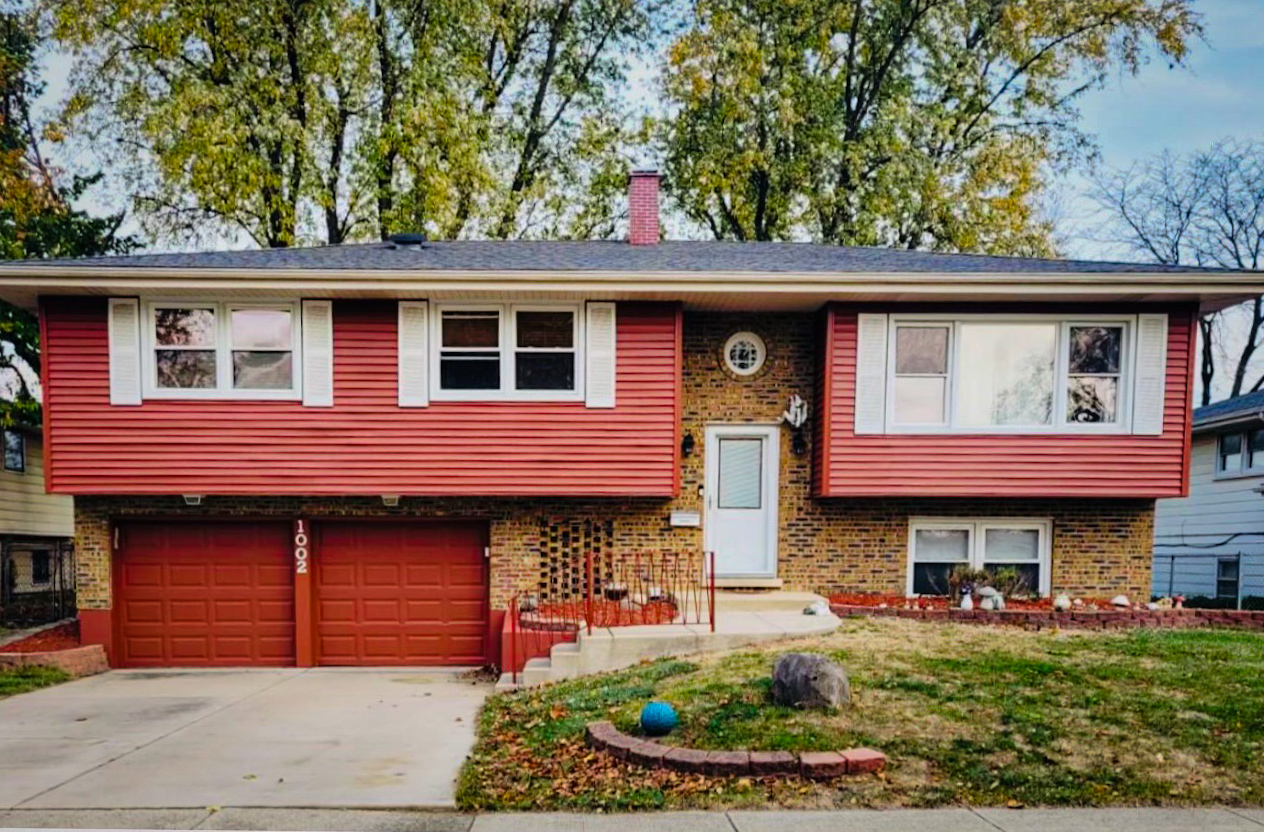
815, 307, 1194, 498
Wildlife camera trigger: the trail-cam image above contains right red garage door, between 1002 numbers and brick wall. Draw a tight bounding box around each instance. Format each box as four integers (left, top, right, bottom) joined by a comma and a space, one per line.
312, 522, 488, 666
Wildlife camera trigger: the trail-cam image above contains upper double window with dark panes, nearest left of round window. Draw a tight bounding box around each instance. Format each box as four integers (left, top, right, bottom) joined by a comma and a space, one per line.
431, 303, 584, 401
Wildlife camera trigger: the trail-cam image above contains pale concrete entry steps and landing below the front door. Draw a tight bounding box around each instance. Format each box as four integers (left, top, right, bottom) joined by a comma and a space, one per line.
495, 592, 839, 690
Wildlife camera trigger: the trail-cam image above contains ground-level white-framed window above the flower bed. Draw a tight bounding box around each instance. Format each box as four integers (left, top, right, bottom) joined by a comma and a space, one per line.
908, 518, 1052, 596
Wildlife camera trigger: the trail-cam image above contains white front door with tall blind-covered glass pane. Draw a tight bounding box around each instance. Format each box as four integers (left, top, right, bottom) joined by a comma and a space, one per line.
703, 425, 780, 578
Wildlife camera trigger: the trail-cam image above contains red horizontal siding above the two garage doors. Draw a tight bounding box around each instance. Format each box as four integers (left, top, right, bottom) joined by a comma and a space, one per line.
43, 298, 680, 497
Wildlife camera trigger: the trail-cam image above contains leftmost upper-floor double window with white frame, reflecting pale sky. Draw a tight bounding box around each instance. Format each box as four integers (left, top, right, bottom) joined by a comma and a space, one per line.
143, 302, 302, 398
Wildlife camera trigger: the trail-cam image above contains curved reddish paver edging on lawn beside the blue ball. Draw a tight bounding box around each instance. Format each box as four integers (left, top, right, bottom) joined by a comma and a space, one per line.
584, 722, 886, 780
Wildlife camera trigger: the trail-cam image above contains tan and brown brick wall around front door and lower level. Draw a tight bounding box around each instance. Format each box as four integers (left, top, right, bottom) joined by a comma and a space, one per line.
76, 307, 1154, 609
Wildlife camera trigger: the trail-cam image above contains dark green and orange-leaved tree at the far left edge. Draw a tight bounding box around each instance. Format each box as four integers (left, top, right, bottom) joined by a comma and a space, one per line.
0, 5, 135, 425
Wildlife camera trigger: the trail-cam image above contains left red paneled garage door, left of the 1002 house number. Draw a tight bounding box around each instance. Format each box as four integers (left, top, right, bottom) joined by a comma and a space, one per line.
114, 522, 295, 668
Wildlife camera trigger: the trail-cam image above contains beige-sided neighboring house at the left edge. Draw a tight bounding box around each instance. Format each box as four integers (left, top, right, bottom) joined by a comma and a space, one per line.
0, 426, 75, 618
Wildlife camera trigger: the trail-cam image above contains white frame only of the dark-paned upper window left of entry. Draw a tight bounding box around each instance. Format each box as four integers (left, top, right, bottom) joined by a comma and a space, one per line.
428, 301, 585, 402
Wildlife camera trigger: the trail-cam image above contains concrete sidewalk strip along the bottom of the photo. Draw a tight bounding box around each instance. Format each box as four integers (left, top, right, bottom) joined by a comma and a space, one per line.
0, 807, 1264, 832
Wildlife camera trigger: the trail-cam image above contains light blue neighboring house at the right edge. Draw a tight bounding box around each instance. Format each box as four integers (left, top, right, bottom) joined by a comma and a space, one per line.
1154, 391, 1264, 603
